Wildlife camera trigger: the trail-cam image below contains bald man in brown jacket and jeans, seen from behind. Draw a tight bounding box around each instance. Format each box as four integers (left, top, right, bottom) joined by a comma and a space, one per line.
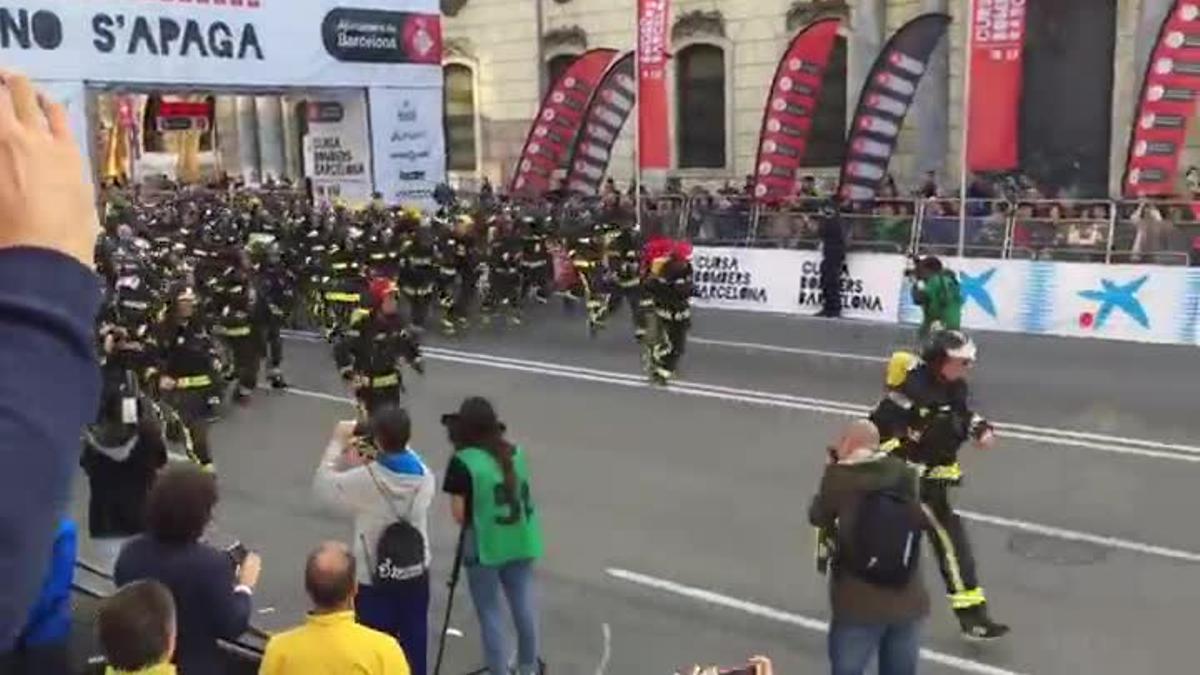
809, 420, 929, 675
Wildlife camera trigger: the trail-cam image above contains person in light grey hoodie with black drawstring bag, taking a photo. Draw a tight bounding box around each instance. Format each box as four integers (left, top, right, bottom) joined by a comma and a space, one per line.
313, 405, 437, 675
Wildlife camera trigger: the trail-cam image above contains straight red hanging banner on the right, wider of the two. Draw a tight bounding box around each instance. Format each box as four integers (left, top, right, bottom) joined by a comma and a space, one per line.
967, 0, 1026, 172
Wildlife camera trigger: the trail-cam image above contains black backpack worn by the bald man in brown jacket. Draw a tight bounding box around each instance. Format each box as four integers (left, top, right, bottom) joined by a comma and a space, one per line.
838, 489, 922, 587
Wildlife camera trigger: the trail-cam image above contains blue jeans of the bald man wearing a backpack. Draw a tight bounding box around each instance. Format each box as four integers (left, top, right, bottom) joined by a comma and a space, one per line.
829, 620, 920, 675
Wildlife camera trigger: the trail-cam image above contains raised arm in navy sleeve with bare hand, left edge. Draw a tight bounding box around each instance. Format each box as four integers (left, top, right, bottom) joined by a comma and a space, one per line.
0, 71, 100, 653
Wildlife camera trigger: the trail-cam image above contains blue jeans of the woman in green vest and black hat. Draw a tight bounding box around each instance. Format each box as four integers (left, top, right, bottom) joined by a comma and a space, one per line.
464, 536, 538, 675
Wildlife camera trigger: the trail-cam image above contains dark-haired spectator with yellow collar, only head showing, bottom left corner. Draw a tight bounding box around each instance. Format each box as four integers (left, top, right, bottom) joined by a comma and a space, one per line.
96, 580, 176, 675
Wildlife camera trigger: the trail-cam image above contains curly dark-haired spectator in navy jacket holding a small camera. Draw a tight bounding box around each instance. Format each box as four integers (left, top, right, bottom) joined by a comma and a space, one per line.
113, 465, 263, 675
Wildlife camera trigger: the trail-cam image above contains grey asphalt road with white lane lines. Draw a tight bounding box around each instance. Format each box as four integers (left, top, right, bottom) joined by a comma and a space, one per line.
70, 305, 1200, 675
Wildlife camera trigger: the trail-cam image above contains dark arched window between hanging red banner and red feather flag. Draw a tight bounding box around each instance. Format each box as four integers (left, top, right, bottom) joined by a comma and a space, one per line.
676, 44, 725, 168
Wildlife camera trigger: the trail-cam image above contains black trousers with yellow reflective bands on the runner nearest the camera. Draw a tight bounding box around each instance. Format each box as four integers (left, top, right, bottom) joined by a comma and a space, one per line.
920, 478, 986, 610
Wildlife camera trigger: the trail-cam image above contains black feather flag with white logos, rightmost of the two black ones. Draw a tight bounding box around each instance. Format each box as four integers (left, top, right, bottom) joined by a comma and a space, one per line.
838, 14, 950, 201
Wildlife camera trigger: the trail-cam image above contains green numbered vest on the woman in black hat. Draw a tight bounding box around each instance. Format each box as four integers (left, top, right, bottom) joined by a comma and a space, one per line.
457, 448, 542, 567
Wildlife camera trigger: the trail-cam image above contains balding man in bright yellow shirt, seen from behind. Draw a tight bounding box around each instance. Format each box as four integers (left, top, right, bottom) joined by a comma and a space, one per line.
258, 542, 412, 675
